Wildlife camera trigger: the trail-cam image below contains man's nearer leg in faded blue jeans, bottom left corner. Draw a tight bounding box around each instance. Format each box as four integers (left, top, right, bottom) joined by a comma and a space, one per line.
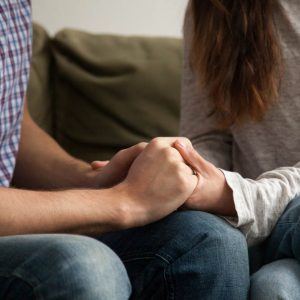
0, 234, 131, 300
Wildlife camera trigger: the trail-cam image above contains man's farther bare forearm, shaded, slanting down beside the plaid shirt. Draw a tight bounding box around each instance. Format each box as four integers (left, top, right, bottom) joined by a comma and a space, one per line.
13, 102, 94, 190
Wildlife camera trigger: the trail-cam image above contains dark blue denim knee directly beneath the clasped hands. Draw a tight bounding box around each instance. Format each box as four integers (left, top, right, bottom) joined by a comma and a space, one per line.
100, 211, 250, 299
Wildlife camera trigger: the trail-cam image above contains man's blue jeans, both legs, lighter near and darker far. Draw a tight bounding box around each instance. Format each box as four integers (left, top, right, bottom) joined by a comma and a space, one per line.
0, 211, 250, 300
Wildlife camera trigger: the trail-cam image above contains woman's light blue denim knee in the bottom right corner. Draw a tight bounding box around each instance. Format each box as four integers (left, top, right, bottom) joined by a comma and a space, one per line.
250, 259, 300, 300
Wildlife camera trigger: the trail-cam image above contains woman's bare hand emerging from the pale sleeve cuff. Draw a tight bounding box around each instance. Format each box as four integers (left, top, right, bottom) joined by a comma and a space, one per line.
175, 139, 236, 216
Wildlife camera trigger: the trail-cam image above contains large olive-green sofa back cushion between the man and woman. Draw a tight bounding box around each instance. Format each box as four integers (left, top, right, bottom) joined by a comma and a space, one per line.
53, 30, 182, 161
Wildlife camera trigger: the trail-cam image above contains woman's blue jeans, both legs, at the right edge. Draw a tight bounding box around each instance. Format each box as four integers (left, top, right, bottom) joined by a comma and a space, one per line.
250, 198, 300, 300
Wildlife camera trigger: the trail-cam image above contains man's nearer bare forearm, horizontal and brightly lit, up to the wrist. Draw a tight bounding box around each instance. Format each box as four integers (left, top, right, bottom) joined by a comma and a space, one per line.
0, 188, 126, 236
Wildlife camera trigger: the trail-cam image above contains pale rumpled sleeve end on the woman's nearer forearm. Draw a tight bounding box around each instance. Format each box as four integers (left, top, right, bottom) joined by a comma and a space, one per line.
223, 162, 300, 245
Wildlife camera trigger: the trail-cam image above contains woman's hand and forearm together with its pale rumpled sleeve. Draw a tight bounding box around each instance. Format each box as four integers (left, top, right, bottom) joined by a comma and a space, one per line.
175, 140, 300, 245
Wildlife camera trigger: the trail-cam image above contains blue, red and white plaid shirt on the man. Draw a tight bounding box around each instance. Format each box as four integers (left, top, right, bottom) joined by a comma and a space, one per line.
0, 0, 31, 187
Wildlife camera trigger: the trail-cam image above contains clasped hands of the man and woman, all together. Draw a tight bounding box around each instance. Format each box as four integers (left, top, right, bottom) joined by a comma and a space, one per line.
91, 138, 235, 225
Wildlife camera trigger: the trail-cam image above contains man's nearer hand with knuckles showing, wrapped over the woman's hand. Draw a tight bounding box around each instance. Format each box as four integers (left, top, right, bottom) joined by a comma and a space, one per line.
118, 138, 198, 227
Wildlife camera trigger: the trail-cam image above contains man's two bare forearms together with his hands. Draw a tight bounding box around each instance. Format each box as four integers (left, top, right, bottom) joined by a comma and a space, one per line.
0, 103, 198, 236
